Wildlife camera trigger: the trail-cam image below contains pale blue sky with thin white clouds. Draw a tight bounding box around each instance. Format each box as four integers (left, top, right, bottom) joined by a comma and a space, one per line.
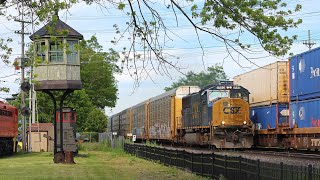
0, 0, 320, 115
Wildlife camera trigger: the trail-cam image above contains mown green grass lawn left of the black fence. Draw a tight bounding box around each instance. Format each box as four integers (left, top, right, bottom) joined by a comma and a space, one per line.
0, 143, 202, 180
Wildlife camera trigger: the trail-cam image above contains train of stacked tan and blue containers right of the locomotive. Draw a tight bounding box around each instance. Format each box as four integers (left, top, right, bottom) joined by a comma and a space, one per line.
234, 48, 320, 150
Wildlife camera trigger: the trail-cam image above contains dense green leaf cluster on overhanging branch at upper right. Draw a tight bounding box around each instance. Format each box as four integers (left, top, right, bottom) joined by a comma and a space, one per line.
191, 0, 302, 56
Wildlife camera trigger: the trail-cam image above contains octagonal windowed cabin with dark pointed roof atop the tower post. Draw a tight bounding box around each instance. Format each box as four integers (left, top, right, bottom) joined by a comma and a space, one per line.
30, 18, 83, 91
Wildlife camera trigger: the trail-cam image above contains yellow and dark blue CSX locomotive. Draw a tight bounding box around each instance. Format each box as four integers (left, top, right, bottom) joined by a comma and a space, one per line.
177, 81, 253, 148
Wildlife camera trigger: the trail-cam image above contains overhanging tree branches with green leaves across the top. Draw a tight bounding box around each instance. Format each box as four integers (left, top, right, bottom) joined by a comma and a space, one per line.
0, 0, 302, 85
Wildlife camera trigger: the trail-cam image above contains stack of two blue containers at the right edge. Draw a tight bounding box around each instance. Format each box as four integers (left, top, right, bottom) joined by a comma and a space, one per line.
290, 48, 320, 128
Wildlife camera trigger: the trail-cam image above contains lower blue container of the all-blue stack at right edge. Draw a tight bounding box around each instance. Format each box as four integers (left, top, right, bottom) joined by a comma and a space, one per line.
290, 98, 320, 128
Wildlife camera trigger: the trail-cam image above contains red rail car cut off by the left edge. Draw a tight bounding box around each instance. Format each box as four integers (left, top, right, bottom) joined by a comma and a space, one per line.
0, 101, 18, 156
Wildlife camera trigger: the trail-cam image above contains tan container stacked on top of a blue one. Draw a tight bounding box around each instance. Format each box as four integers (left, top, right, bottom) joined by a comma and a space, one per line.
233, 61, 289, 107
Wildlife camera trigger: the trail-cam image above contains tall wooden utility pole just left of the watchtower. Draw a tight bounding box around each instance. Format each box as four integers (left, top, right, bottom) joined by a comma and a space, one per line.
15, 1, 30, 152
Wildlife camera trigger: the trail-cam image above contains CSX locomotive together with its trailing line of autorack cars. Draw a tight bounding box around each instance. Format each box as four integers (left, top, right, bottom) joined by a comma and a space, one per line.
108, 81, 253, 148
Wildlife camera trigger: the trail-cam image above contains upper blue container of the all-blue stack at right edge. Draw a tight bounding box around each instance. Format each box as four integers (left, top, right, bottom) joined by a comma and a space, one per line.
289, 48, 320, 101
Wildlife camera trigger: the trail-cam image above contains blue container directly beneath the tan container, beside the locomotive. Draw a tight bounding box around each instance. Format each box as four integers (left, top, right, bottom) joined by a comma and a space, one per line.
250, 104, 289, 129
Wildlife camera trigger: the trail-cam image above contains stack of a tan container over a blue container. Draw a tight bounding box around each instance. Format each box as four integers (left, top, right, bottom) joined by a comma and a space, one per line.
234, 61, 289, 130
